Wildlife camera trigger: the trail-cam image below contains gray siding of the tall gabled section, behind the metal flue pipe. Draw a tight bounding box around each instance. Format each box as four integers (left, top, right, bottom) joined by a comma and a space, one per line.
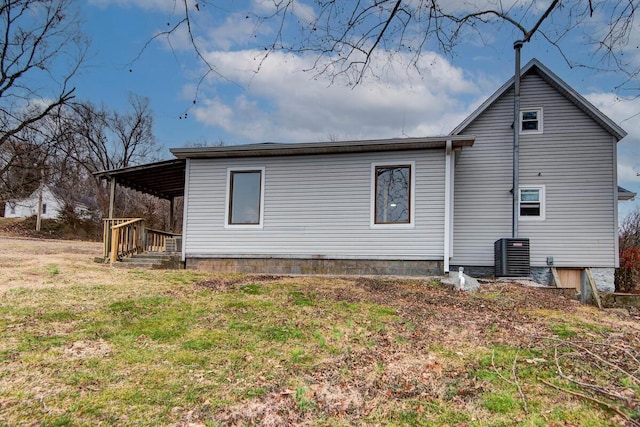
452, 73, 616, 267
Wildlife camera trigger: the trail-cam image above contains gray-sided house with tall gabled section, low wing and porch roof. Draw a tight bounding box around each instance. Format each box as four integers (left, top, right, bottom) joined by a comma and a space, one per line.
98, 59, 633, 290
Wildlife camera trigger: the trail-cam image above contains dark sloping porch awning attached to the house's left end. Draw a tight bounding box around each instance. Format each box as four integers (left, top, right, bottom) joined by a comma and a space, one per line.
94, 159, 186, 200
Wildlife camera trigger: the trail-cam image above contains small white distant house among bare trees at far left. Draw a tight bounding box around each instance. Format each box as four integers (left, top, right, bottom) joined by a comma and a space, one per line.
4, 184, 91, 219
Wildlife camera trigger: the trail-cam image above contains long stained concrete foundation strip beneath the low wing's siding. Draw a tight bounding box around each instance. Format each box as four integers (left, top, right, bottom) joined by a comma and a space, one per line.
185, 258, 443, 276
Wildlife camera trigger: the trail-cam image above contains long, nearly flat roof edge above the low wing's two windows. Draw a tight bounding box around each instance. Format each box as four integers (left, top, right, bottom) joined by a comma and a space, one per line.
170, 135, 474, 159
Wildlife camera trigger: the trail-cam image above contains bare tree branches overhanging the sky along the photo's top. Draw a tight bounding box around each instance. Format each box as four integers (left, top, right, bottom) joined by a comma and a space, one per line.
152, 0, 640, 93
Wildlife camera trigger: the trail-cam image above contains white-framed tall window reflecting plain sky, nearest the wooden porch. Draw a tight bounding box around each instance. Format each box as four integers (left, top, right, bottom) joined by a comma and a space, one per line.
225, 167, 264, 228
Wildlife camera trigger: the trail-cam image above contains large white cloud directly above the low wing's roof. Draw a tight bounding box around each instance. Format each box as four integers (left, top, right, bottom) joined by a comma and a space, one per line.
194, 51, 478, 143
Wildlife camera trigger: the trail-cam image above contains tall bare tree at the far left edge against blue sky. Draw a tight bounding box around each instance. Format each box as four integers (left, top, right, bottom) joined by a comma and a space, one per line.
0, 0, 88, 202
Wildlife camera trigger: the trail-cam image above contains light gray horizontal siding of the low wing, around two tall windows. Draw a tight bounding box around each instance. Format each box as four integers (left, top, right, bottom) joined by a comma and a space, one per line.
184, 149, 445, 260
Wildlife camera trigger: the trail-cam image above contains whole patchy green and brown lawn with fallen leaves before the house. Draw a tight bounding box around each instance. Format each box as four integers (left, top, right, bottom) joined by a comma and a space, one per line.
0, 237, 640, 426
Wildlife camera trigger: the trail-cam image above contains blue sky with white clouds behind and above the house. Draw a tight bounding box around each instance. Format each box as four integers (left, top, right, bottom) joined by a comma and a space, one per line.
75, 0, 640, 217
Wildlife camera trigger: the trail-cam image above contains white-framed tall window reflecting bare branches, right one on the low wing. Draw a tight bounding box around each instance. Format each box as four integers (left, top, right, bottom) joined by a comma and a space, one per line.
371, 162, 415, 228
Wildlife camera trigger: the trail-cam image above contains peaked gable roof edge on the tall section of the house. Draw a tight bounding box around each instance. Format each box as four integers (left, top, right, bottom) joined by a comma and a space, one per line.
451, 58, 627, 141
